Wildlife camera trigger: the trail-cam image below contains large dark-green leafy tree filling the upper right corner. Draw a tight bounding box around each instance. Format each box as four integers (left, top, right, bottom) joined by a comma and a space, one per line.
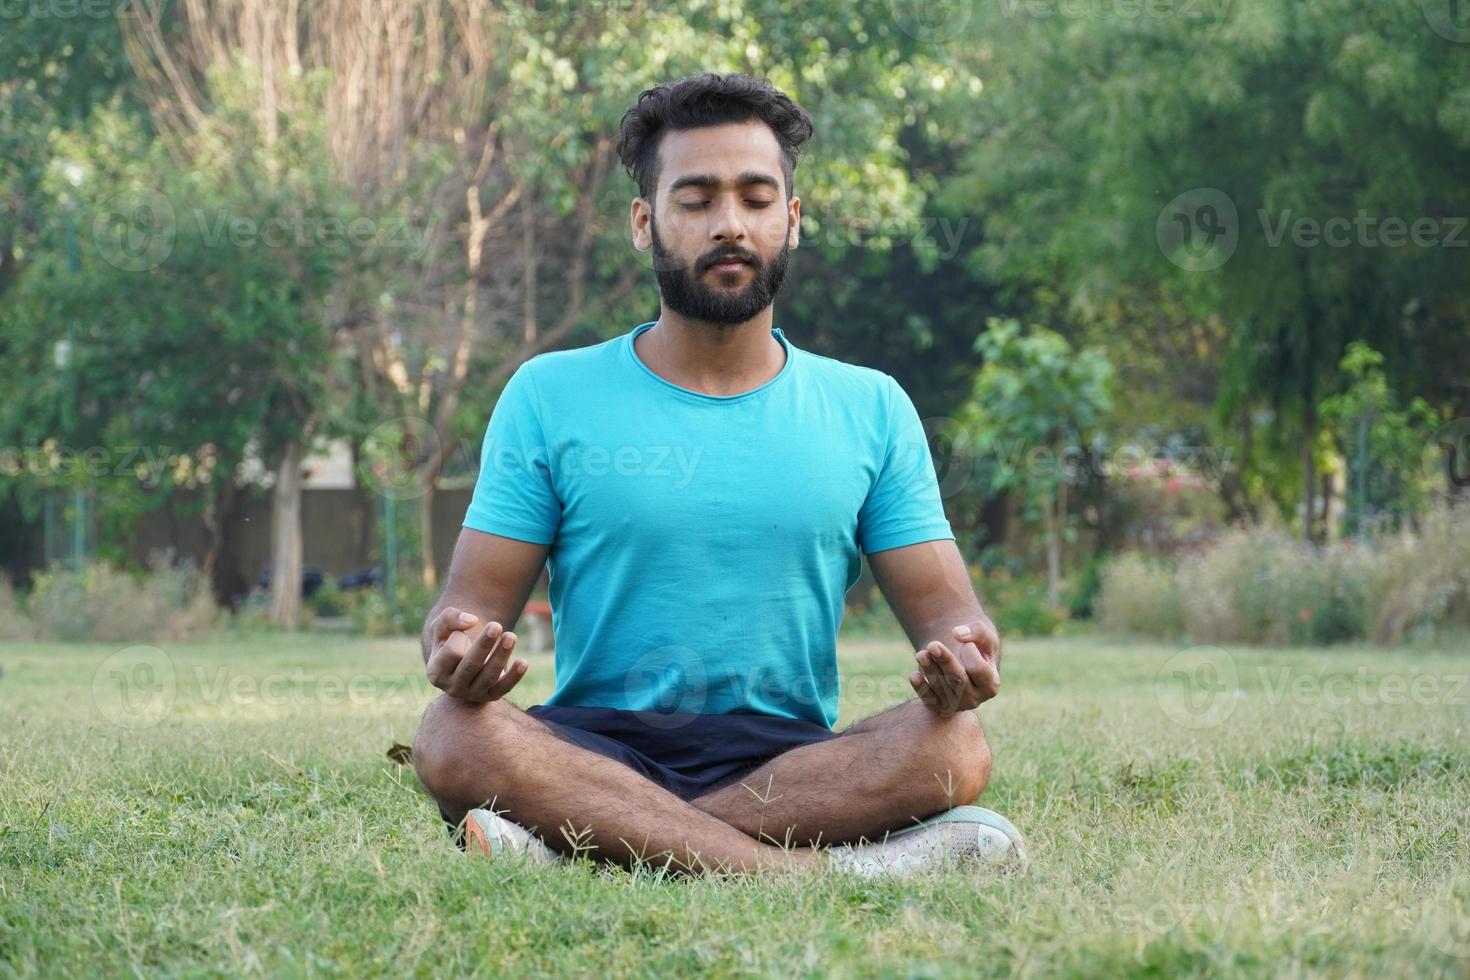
953, 0, 1470, 536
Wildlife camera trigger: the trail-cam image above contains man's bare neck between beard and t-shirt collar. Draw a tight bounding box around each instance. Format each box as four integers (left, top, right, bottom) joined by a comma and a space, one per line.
634, 306, 786, 395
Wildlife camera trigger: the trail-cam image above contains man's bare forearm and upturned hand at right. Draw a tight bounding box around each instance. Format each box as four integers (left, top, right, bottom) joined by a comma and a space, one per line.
867, 541, 1001, 717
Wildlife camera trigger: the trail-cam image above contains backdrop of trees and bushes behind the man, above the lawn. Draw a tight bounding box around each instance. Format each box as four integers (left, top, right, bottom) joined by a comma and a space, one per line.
0, 0, 1470, 642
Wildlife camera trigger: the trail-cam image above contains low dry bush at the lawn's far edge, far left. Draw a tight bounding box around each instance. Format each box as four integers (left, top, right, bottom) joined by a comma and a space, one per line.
26, 555, 218, 642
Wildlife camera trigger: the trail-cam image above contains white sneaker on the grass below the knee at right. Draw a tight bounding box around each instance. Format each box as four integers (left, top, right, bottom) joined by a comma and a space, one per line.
828, 807, 1028, 877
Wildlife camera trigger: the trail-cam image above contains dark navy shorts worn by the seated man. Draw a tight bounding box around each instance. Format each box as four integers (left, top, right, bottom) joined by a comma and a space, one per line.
526, 704, 836, 799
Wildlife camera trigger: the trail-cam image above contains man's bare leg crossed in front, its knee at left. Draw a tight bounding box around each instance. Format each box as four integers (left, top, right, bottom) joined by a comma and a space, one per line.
413, 695, 820, 871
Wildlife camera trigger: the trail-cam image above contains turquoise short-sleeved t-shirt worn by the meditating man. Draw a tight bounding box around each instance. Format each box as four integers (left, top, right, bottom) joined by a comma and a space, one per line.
465, 323, 954, 727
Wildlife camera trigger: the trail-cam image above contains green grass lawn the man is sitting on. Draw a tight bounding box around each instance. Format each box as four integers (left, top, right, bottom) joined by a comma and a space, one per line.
0, 636, 1470, 977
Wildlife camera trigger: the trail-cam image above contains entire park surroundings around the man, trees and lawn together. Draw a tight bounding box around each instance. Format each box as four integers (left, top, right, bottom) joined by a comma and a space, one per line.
0, 0, 1470, 977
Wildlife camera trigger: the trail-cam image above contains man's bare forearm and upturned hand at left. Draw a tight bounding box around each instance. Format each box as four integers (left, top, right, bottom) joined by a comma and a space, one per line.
422, 527, 550, 701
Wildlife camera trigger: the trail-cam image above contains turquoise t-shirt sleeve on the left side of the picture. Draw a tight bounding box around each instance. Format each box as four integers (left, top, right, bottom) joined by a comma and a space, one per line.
465, 361, 562, 545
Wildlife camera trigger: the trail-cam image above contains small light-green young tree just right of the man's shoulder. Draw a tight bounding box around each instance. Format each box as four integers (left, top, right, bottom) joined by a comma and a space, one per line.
961, 320, 1113, 605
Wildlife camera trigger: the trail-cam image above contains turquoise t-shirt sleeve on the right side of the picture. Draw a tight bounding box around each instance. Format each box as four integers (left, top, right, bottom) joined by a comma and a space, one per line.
857, 376, 954, 554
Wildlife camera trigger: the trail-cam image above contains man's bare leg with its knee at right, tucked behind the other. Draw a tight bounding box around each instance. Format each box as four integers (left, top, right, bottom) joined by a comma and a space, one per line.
694, 699, 991, 845
